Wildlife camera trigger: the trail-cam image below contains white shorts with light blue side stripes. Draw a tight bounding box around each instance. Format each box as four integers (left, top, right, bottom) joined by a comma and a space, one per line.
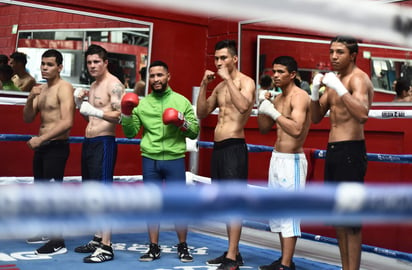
268, 151, 308, 237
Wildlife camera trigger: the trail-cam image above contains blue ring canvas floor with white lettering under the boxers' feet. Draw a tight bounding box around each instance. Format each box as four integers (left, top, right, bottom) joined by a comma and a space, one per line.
0, 223, 412, 270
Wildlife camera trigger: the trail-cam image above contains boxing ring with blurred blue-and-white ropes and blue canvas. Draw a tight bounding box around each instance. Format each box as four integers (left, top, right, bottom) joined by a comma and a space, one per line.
0, 124, 412, 270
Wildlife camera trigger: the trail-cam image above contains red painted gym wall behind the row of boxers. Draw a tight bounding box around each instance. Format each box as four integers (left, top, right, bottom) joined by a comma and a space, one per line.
0, 0, 412, 252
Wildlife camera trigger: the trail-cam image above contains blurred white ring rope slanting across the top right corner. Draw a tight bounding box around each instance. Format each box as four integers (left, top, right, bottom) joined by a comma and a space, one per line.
107, 0, 412, 46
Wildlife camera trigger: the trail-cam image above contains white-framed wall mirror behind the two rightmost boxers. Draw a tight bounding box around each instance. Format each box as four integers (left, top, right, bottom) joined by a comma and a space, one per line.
256, 35, 412, 94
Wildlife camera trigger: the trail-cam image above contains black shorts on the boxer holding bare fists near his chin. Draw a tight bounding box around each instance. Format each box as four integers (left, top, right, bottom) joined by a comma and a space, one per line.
211, 139, 248, 182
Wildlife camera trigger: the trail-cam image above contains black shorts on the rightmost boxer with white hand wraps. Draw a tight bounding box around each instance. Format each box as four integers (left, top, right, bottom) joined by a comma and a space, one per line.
324, 140, 368, 183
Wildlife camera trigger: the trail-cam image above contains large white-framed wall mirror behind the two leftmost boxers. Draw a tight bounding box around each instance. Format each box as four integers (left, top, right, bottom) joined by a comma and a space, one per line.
2, 1, 153, 96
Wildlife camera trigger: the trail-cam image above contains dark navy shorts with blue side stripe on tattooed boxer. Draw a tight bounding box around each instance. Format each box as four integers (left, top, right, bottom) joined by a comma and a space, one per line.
82, 136, 117, 183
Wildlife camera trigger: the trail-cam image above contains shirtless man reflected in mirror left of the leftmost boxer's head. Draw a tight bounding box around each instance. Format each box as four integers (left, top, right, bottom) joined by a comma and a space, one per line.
10, 52, 36, 92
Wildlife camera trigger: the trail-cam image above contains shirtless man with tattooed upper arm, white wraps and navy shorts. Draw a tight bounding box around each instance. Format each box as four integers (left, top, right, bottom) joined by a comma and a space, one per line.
74, 45, 124, 263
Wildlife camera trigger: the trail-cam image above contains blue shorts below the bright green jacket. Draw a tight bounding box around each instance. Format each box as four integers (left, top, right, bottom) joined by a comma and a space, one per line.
142, 157, 186, 185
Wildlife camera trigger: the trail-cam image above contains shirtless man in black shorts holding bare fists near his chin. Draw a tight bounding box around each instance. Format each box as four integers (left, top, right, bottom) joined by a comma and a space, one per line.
197, 40, 256, 270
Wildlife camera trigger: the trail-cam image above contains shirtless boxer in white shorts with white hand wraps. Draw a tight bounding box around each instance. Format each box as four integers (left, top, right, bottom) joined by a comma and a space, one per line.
258, 56, 311, 270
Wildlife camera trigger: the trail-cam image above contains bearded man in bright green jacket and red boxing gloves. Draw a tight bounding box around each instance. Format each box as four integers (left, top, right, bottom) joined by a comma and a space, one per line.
121, 61, 199, 262
